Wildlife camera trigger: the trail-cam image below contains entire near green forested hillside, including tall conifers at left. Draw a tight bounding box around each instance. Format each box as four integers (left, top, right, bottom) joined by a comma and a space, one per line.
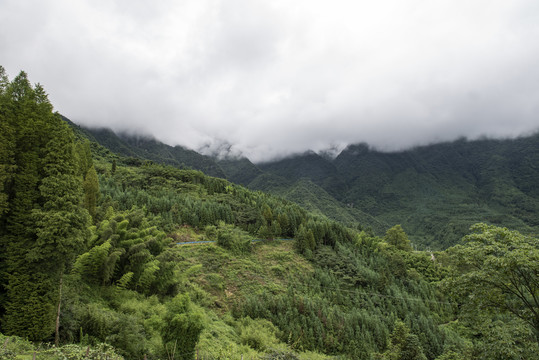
0, 67, 539, 360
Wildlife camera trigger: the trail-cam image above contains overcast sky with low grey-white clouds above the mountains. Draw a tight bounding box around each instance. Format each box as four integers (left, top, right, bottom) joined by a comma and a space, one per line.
0, 0, 539, 161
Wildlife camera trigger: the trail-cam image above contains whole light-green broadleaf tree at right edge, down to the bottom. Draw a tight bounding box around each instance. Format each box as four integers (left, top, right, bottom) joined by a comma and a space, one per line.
444, 224, 539, 359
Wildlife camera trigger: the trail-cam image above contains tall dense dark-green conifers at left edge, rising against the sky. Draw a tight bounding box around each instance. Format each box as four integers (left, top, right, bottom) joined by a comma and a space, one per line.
0, 69, 89, 340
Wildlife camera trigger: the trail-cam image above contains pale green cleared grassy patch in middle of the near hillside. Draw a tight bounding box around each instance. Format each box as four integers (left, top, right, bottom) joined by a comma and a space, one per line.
177, 240, 314, 311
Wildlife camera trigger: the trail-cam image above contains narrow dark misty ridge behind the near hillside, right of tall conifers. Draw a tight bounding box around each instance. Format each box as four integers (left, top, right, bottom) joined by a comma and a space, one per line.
64, 118, 226, 178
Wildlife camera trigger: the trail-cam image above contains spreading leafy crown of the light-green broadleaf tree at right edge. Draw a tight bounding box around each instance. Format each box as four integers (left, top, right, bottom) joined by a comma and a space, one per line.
446, 224, 539, 342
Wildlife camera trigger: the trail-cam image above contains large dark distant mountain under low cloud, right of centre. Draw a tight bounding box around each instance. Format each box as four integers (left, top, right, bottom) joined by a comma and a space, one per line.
223, 135, 539, 249
